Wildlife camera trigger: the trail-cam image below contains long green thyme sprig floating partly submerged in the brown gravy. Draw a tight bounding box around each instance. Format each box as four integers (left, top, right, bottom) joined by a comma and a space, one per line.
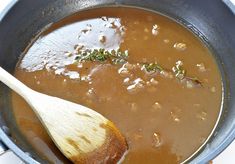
75, 48, 202, 86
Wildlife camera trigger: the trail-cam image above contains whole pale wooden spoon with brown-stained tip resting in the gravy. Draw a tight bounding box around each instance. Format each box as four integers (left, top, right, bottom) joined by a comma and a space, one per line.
0, 67, 127, 163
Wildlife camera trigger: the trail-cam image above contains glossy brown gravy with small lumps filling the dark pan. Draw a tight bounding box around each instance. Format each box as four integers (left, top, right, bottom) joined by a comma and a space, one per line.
12, 8, 222, 164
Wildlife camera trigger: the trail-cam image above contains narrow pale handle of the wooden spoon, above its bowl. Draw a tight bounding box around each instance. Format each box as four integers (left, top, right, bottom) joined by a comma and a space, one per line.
0, 67, 32, 97
